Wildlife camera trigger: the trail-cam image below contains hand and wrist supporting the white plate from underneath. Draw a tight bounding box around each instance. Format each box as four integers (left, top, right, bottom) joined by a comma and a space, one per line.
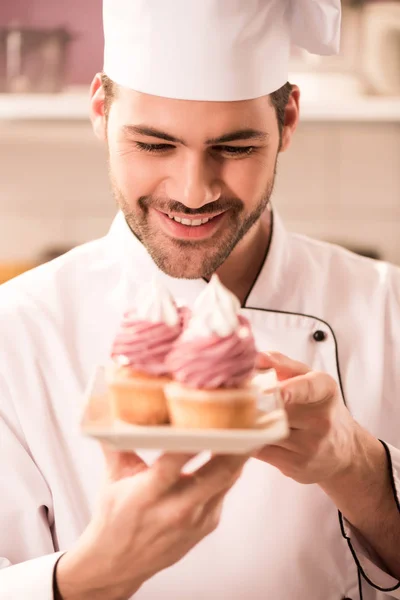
57, 449, 248, 600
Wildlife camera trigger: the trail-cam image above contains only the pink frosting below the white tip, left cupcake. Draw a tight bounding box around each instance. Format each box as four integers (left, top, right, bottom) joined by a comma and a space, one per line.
111, 308, 190, 375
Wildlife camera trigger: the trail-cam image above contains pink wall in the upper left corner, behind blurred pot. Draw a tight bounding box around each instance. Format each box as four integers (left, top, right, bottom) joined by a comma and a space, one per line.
0, 0, 103, 84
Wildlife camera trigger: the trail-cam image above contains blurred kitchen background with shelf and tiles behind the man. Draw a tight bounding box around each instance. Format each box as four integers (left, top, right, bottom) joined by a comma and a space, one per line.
0, 0, 400, 283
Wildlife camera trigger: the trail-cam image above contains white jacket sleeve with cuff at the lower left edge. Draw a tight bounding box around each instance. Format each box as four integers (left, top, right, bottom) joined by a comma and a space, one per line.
0, 380, 60, 600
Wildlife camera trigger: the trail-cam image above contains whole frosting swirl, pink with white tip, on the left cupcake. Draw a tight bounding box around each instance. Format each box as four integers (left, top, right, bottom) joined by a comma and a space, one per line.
111, 282, 188, 375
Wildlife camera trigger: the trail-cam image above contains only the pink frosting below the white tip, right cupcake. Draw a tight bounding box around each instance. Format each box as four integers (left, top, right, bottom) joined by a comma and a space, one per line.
167, 316, 257, 389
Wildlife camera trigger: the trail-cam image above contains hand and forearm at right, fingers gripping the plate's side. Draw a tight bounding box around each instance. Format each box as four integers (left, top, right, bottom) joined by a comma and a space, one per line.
257, 353, 400, 598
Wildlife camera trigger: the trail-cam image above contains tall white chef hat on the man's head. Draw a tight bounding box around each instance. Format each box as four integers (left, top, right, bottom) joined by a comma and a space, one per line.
103, 0, 341, 101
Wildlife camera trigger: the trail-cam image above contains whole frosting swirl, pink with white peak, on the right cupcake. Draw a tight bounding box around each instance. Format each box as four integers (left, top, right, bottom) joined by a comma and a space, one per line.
167, 275, 257, 389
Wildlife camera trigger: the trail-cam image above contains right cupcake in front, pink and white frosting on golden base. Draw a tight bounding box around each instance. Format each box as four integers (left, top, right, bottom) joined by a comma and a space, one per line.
165, 275, 257, 429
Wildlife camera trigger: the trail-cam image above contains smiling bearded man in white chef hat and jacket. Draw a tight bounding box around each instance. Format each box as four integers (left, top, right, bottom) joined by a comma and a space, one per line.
0, 0, 400, 600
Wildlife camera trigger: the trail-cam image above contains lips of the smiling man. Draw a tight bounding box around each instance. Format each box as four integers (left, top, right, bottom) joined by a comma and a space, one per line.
152, 209, 227, 240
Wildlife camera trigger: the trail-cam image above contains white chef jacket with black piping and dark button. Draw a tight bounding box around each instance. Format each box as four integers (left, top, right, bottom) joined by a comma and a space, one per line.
0, 214, 400, 600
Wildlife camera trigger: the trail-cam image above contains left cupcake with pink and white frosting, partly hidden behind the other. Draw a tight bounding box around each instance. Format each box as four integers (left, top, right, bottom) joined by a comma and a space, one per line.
107, 281, 188, 425
